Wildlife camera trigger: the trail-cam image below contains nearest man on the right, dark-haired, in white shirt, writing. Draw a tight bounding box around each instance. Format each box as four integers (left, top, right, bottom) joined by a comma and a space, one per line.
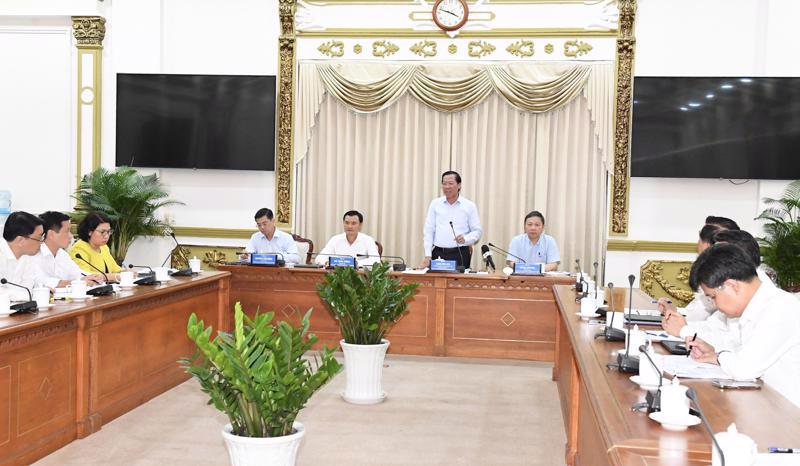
686, 243, 800, 406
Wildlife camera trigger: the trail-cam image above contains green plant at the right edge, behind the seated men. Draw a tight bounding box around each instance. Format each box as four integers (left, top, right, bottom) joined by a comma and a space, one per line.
756, 180, 800, 293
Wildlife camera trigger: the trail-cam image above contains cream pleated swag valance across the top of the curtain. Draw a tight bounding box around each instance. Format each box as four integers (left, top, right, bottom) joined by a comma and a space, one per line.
317, 63, 591, 113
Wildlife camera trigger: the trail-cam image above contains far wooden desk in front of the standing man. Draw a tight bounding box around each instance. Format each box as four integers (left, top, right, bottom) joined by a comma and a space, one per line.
220, 266, 574, 361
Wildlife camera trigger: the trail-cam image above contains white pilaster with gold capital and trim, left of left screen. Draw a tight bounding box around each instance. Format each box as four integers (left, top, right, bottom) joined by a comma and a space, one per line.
72, 16, 106, 183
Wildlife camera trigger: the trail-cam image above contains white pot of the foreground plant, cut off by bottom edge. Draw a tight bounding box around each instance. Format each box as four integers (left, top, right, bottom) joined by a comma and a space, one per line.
222, 421, 306, 466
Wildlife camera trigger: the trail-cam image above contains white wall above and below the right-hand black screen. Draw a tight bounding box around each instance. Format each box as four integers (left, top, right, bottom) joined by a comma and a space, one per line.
606, 0, 800, 283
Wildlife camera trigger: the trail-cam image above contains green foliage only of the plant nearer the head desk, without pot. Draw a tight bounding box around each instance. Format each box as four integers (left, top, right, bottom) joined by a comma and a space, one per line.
317, 262, 419, 345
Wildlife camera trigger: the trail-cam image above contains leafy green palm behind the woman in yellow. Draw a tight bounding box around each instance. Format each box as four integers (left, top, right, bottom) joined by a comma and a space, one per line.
72, 167, 183, 263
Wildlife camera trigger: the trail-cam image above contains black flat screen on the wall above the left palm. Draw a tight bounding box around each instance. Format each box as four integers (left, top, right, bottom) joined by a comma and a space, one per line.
116, 74, 275, 171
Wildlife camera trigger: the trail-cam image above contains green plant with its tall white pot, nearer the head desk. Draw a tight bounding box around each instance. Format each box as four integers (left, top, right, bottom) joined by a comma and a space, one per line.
317, 262, 419, 404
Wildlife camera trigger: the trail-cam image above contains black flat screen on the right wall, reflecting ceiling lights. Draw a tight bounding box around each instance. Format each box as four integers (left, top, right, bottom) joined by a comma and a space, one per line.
631, 77, 800, 180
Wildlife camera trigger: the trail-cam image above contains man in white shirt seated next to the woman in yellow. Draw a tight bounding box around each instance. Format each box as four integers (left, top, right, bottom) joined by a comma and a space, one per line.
36, 211, 105, 288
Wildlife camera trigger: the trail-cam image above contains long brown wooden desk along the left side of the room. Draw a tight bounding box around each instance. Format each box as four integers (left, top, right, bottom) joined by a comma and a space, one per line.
0, 272, 230, 464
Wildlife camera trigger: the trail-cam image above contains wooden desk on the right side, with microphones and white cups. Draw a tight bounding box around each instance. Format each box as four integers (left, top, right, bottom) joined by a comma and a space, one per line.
553, 286, 800, 466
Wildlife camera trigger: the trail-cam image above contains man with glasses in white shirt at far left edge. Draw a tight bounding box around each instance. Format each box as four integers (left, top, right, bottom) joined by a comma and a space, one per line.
0, 211, 44, 301
